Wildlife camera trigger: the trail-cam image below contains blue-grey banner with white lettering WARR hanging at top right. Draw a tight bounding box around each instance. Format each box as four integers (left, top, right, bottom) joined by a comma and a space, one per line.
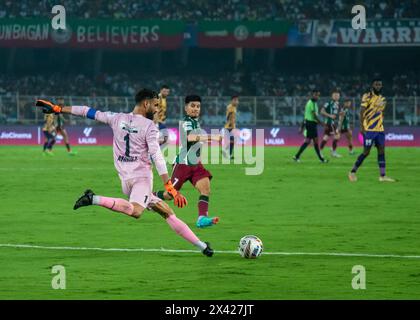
287, 19, 420, 47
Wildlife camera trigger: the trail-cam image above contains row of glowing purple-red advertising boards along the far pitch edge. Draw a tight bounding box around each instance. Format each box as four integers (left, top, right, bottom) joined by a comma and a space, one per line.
0, 125, 420, 147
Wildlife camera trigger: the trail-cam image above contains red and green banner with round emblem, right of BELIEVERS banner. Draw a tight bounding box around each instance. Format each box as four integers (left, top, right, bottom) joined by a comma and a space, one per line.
197, 21, 290, 48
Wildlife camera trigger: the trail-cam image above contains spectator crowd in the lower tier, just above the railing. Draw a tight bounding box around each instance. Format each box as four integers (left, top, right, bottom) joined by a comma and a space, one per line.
0, 71, 420, 97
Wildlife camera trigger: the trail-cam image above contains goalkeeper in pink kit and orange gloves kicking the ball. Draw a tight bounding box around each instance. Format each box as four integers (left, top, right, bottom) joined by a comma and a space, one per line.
36, 89, 213, 257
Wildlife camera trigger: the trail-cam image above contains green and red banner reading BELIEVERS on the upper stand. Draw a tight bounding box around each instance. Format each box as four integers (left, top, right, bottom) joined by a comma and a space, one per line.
0, 18, 186, 49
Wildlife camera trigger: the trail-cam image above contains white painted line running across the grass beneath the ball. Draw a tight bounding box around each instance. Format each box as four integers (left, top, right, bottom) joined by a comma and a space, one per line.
0, 243, 420, 259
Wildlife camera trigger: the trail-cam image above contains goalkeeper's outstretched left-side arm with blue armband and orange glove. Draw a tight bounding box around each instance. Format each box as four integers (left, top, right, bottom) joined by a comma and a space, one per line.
35, 100, 114, 124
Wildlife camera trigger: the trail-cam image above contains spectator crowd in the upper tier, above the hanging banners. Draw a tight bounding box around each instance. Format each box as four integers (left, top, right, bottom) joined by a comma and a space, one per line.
0, 0, 420, 21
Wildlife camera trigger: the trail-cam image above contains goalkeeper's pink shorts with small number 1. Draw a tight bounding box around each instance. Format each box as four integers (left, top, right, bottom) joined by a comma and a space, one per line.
121, 177, 162, 210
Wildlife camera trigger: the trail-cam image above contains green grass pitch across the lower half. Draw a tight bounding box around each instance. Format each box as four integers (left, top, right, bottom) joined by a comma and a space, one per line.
0, 146, 420, 299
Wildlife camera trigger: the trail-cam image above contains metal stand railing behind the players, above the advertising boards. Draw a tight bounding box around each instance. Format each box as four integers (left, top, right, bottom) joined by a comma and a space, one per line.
0, 93, 420, 126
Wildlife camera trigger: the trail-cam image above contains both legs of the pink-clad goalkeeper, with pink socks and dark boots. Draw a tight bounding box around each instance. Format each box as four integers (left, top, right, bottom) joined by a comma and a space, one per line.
73, 190, 213, 257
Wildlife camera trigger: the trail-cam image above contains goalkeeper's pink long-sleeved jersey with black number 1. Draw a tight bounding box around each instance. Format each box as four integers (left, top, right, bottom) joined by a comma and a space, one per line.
71, 106, 168, 180
